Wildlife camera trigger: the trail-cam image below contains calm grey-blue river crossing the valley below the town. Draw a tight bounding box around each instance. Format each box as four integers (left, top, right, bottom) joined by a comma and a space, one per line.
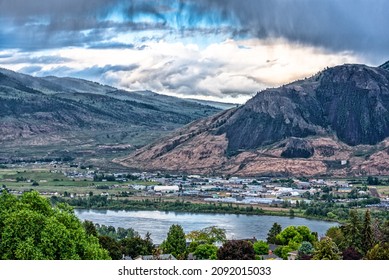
75, 209, 339, 244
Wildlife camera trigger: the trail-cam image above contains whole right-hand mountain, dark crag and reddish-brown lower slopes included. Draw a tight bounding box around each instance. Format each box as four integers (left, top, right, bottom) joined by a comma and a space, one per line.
120, 64, 389, 176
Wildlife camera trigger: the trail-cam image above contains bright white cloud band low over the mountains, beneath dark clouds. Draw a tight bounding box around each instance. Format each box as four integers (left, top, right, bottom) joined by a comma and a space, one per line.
0, 39, 368, 102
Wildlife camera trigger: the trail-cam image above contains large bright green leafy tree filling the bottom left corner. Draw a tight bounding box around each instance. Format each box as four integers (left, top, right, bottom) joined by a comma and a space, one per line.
0, 192, 109, 260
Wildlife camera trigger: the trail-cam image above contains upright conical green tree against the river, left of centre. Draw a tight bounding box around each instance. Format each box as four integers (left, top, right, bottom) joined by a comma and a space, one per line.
160, 225, 188, 259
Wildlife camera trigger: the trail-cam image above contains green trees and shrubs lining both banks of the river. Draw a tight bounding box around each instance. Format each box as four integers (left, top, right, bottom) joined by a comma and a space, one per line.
0, 190, 389, 260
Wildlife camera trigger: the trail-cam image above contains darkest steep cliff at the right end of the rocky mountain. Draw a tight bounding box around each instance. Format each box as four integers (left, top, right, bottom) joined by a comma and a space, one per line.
316, 65, 389, 146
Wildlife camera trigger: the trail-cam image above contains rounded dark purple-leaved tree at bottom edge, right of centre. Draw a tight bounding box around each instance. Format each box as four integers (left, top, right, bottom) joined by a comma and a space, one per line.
217, 240, 255, 260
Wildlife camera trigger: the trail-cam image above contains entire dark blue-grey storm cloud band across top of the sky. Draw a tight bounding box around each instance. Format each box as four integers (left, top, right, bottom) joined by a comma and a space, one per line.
0, 0, 389, 61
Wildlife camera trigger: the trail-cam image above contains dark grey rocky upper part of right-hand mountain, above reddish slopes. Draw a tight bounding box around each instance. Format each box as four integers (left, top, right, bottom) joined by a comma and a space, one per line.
219, 65, 389, 151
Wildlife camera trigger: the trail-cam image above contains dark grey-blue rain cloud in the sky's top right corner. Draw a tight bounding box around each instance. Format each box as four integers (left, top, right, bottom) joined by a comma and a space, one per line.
197, 0, 389, 61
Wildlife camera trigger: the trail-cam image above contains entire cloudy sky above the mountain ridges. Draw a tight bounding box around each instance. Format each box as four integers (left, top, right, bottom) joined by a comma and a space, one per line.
0, 0, 389, 103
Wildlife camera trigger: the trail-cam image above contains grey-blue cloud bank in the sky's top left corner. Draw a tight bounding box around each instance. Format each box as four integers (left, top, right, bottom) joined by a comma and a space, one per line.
0, 0, 161, 50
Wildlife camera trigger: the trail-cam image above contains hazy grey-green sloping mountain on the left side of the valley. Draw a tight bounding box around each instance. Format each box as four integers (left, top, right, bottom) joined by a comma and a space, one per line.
0, 68, 221, 162
